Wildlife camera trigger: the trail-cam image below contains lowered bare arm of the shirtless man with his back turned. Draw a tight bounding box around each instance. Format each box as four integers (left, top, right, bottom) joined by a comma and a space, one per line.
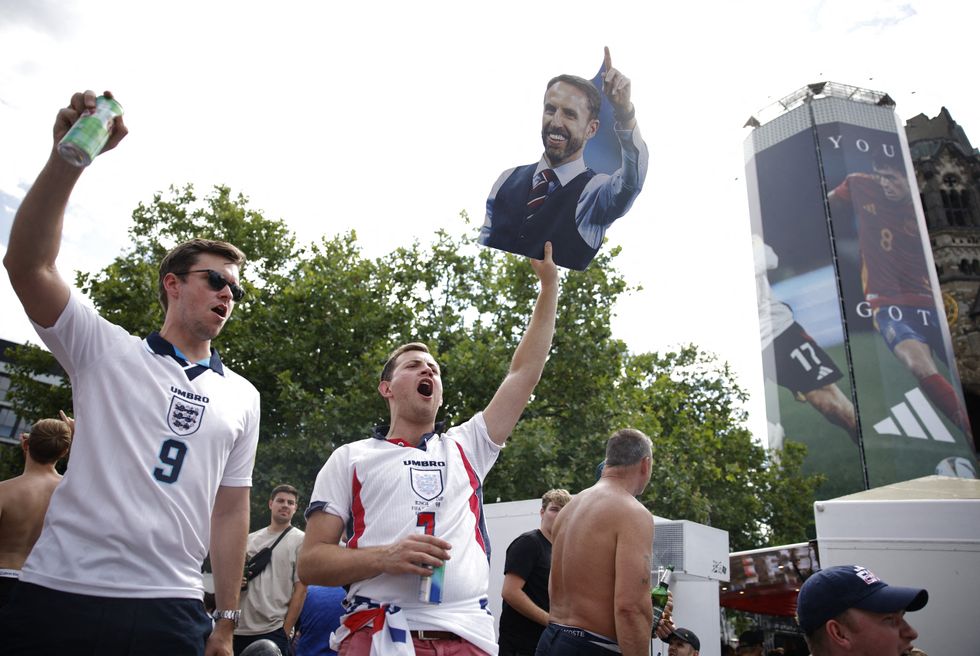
613, 507, 653, 656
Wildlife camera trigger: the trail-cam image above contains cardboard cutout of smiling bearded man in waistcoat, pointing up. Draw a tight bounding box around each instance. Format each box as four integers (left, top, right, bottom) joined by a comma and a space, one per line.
479, 48, 649, 271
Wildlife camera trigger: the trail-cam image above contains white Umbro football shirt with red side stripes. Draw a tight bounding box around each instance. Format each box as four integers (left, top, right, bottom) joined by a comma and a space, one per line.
307, 413, 501, 624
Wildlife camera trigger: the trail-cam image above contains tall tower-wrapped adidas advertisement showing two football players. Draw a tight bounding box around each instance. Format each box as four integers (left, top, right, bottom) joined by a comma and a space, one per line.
747, 98, 975, 498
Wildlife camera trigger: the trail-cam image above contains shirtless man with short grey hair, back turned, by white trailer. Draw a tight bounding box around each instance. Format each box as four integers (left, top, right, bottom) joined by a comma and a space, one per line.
536, 428, 674, 656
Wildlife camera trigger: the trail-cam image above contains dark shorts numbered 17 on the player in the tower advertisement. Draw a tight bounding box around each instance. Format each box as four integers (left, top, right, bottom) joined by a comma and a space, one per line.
763, 321, 844, 394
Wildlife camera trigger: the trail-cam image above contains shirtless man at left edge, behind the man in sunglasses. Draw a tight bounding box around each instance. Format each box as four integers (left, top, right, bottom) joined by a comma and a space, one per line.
0, 413, 73, 607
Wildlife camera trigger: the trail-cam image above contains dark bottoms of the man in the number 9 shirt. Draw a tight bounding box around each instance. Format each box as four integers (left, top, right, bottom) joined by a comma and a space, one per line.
0, 581, 211, 656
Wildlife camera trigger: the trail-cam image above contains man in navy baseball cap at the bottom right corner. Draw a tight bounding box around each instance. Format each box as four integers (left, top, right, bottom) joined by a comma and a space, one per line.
796, 565, 929, 656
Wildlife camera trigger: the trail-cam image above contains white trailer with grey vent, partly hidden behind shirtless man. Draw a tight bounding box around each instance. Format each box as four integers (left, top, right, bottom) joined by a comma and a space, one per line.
484, 499, 729, 656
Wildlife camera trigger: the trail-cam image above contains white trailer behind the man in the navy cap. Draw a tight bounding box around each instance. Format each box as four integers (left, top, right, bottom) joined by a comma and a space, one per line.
814, 476, 980, 654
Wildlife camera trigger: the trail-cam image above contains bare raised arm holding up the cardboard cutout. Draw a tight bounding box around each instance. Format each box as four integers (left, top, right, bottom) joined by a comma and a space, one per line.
483, 242, 558, 444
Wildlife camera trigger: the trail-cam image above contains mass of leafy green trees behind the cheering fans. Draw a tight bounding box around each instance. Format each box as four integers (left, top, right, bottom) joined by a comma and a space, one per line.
5, 186, 828, 549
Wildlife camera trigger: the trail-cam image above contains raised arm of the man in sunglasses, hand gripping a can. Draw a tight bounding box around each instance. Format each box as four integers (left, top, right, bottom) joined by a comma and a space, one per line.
3, 91, 127, 328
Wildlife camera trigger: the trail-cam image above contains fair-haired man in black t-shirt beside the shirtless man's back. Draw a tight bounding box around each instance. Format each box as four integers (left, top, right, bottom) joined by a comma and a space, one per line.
498, 490, 572, 656
